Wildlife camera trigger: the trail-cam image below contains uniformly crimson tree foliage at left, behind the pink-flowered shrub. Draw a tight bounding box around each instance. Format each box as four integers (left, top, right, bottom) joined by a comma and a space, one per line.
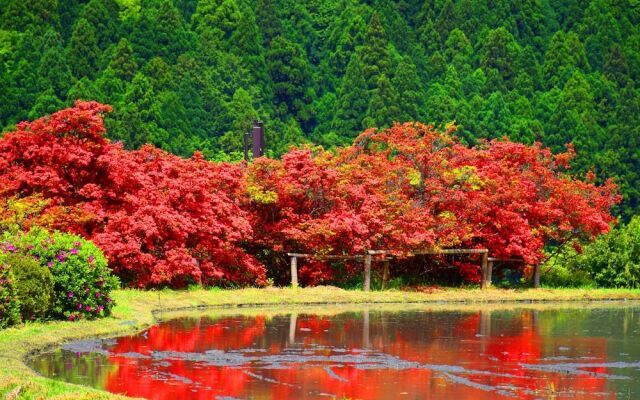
0, 102, 265, 287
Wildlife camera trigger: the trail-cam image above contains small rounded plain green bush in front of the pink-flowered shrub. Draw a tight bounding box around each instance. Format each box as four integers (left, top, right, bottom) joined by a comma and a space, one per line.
0, 252, 53, 321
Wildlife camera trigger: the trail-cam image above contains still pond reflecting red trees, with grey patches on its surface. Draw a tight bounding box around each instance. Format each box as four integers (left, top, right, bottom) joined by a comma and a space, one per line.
31, 303, 640, 400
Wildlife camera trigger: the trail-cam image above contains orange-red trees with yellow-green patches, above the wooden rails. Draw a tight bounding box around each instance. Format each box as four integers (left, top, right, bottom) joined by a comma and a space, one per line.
247, 123, 619, 281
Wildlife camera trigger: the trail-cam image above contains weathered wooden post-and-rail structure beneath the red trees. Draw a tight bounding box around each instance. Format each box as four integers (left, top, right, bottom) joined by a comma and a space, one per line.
287, 249, 524, 292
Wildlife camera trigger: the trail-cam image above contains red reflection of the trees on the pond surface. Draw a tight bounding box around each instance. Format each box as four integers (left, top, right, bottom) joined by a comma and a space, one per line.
105, 311, 615, 400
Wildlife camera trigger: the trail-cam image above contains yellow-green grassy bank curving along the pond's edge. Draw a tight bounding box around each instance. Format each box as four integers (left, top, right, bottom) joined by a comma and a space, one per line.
0, 287, 640, 399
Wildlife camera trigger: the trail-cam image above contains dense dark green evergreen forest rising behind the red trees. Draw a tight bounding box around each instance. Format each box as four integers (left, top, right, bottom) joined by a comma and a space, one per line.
0, 0, 640, 217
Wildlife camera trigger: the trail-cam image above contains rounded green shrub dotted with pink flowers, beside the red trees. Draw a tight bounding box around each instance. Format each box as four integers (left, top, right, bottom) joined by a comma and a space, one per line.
5, 229, 119, 320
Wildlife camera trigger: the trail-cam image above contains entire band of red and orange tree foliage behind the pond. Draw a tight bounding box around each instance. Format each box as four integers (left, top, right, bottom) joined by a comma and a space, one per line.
0, 102, 619, 287
